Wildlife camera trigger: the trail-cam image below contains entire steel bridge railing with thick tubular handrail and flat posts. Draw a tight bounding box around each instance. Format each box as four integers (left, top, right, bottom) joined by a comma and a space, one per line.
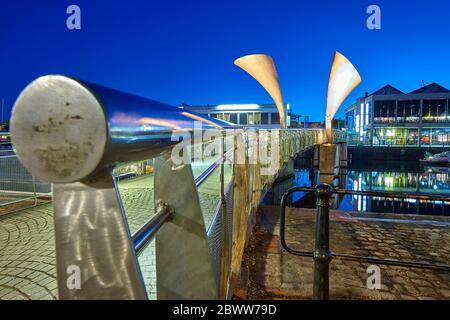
7, 76, 330, 299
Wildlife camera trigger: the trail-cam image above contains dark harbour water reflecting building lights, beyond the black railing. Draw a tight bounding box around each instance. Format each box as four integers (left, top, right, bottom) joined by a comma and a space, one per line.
293, 162, 450, 216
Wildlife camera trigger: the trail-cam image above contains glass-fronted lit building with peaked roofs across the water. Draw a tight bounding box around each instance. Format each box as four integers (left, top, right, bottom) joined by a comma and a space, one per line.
345, 83, 450, 147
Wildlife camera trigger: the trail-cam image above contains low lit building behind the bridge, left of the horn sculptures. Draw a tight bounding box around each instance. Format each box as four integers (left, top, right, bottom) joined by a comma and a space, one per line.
180, 104, 290, 128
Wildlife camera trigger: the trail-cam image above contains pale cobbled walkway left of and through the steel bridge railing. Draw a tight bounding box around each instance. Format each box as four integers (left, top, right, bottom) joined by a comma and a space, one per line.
0, 174, 220, 300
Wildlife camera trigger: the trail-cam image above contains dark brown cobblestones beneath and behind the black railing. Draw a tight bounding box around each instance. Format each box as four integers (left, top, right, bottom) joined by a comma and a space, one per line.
235, 206, 450, 299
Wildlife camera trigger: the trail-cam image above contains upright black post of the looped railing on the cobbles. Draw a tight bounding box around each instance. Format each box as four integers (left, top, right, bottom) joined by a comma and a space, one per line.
313, 184, 333, 300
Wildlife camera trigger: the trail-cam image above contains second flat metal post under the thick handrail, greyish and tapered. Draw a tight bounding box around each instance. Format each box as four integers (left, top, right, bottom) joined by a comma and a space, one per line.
154, 154, 217, 300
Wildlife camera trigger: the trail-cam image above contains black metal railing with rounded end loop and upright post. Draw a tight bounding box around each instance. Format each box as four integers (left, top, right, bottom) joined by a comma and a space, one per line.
280, 184, 450, 300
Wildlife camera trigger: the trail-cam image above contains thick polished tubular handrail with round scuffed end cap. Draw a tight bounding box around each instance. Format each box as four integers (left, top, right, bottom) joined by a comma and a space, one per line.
11, 75, 235, 183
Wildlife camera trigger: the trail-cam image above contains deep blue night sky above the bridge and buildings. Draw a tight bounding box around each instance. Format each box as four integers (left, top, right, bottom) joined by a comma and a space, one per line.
0, 0, 450, 120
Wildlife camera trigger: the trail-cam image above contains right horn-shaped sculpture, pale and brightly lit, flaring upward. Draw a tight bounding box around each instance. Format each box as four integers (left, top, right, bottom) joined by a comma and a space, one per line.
325, 51, 361, 143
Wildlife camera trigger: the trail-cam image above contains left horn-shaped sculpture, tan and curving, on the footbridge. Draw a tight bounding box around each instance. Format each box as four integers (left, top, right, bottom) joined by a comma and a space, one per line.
234, 54, 285, 128
